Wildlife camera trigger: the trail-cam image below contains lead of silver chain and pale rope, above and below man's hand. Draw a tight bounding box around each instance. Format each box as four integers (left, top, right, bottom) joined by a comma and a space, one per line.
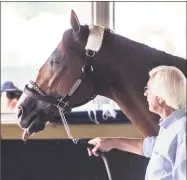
56, 105, 112, 180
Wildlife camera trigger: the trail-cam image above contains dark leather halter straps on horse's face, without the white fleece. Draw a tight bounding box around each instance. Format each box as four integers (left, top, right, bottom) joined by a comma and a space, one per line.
23, 50, 97, 111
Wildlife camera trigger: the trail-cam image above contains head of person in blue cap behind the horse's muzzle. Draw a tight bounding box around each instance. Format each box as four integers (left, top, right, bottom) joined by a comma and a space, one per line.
1, 81, 22, 110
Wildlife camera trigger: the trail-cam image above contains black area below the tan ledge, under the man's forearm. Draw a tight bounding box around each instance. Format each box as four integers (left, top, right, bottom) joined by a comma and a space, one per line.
1, 139, 148, 180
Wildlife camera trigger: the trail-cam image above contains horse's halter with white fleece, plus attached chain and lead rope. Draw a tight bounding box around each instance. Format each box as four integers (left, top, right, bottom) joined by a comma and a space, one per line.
23, 26, 112, 180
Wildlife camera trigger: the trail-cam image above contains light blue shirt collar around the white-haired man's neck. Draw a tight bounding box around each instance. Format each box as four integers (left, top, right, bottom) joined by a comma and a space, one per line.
159, 108, 187, 129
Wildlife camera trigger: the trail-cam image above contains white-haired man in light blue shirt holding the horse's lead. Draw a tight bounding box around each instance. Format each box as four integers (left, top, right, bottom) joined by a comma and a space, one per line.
88, 66, 186, 180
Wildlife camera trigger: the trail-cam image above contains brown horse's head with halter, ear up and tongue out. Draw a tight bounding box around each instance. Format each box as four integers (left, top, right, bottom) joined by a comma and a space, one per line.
18, 11, 104, 139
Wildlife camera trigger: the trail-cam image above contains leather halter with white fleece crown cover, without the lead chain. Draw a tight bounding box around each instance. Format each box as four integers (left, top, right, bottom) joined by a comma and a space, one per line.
24, 25, 104, 112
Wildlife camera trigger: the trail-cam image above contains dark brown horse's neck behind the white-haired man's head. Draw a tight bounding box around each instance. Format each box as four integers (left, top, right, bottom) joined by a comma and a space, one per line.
98, 34, 186, 136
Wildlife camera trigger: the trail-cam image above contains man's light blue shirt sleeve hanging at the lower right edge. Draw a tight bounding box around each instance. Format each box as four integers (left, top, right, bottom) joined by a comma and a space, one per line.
173, 133, 187, 180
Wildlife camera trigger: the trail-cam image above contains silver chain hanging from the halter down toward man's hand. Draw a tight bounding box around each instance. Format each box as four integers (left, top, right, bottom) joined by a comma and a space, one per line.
57, 106, 79, 144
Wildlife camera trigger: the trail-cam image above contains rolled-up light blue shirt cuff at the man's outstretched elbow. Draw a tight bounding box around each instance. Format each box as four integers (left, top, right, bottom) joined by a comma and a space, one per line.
143, 136, 157, 158
